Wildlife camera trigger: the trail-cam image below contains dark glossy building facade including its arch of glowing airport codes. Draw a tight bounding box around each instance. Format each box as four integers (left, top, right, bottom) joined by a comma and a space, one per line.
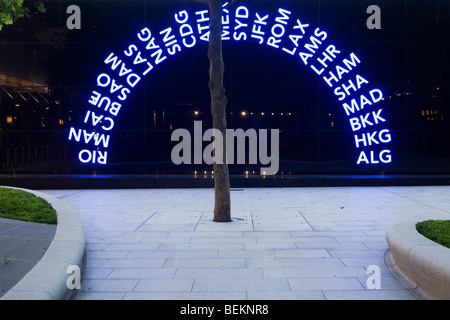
0, 0, 450, 182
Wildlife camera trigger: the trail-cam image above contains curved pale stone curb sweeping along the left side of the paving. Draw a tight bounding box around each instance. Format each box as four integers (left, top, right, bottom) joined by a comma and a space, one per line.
0, 187, 85, 300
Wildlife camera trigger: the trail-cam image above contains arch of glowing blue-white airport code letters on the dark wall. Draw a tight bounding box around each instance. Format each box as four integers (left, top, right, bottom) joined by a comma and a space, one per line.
68, 4, 392, 170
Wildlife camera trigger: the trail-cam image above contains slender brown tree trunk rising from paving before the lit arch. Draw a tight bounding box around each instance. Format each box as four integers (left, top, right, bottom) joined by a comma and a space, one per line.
208, 0, 231, 222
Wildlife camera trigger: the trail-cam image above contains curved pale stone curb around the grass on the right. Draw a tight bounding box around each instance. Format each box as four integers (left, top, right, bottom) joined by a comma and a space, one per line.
386, 221, 450, 300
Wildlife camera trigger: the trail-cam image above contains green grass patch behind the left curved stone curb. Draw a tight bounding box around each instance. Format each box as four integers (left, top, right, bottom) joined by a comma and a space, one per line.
0, 188, 58, 224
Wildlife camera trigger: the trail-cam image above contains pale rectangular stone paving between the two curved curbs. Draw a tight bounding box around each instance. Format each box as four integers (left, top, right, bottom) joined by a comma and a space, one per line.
43, 187, 450, 300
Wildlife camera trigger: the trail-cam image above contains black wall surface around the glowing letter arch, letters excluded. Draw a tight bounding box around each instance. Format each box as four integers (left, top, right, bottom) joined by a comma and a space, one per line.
0, 0, 450, 174
